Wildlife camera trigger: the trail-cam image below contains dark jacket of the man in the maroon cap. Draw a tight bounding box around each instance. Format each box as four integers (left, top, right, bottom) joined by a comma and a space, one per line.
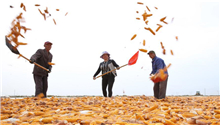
31, 49, 53, 76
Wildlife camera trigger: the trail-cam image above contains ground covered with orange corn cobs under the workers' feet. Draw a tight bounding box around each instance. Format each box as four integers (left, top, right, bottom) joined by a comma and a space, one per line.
1, 96, 220, 125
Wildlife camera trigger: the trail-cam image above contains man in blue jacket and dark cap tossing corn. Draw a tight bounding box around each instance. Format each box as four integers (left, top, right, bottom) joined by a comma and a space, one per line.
148, 50, 168, 99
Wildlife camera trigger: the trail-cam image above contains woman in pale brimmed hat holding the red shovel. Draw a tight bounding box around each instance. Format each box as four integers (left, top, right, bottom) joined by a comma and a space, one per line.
93, 51, 120, 97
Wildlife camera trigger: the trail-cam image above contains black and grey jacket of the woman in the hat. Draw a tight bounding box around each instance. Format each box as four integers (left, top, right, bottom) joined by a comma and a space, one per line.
94, 59, 119, 77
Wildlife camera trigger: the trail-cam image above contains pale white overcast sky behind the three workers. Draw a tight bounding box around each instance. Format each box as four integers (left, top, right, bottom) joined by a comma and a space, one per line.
0, 0, 220, 96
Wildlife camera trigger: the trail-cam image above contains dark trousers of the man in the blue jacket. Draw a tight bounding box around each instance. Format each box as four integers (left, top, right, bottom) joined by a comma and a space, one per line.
154, 77, 168, 99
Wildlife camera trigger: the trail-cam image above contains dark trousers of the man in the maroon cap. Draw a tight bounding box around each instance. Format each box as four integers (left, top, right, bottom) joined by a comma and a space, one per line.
34, 75, 48, 97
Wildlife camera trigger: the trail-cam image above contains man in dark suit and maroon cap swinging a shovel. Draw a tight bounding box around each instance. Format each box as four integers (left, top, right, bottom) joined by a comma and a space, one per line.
30, 41, 53, 97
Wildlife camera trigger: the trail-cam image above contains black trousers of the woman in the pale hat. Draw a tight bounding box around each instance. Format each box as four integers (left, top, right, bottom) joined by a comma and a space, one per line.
102, 73, 115, 97
